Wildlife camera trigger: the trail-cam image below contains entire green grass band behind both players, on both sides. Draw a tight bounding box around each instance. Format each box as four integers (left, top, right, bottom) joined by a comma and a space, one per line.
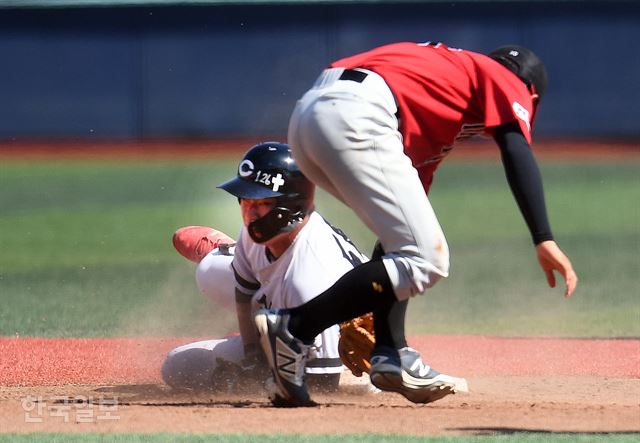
0, 160, 640, 337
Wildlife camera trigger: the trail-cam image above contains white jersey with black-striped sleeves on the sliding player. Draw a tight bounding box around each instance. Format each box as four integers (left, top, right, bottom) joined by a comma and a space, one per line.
232, 212, 368, 374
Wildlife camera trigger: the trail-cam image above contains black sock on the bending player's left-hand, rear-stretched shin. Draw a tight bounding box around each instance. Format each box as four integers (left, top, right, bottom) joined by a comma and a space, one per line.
289, 260, 397, 343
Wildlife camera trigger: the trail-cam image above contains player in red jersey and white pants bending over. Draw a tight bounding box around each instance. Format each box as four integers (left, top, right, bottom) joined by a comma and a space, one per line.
255, 42, 578, 406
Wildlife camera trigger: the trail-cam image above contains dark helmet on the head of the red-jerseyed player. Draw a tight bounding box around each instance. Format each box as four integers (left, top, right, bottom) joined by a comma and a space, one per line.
489, 45, 547, 99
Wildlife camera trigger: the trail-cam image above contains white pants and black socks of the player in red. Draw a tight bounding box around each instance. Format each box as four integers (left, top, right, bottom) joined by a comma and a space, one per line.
289, 70, 456, 399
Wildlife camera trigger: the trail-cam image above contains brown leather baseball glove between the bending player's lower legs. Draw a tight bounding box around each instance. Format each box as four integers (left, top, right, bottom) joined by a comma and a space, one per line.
338, 313, 376, 377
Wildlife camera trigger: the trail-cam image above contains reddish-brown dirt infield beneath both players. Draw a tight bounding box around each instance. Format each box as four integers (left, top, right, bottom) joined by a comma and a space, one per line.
0, 336, 640, 435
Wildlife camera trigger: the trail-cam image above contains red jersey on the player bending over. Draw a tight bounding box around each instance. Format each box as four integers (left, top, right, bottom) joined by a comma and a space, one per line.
331, 43, 534, 190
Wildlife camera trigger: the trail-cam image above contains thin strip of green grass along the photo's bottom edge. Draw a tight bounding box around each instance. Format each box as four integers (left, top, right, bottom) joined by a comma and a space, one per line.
0, 432, 638, 443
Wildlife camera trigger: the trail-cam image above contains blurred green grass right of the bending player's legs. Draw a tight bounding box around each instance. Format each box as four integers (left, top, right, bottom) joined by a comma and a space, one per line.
410, 163, 640, 337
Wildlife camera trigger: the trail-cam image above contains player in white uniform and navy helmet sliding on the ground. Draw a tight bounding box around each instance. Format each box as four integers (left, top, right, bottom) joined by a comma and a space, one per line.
162, 142, 470, 401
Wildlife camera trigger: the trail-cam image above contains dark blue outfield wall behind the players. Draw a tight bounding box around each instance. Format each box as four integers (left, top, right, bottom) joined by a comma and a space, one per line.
0, 1, 640, 140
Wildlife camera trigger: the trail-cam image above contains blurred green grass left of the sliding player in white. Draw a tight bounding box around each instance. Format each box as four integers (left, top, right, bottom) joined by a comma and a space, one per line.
0, 162, 240, 336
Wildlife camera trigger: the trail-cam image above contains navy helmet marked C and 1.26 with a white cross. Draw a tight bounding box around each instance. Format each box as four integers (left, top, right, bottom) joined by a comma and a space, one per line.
218, 142, 315, 243
